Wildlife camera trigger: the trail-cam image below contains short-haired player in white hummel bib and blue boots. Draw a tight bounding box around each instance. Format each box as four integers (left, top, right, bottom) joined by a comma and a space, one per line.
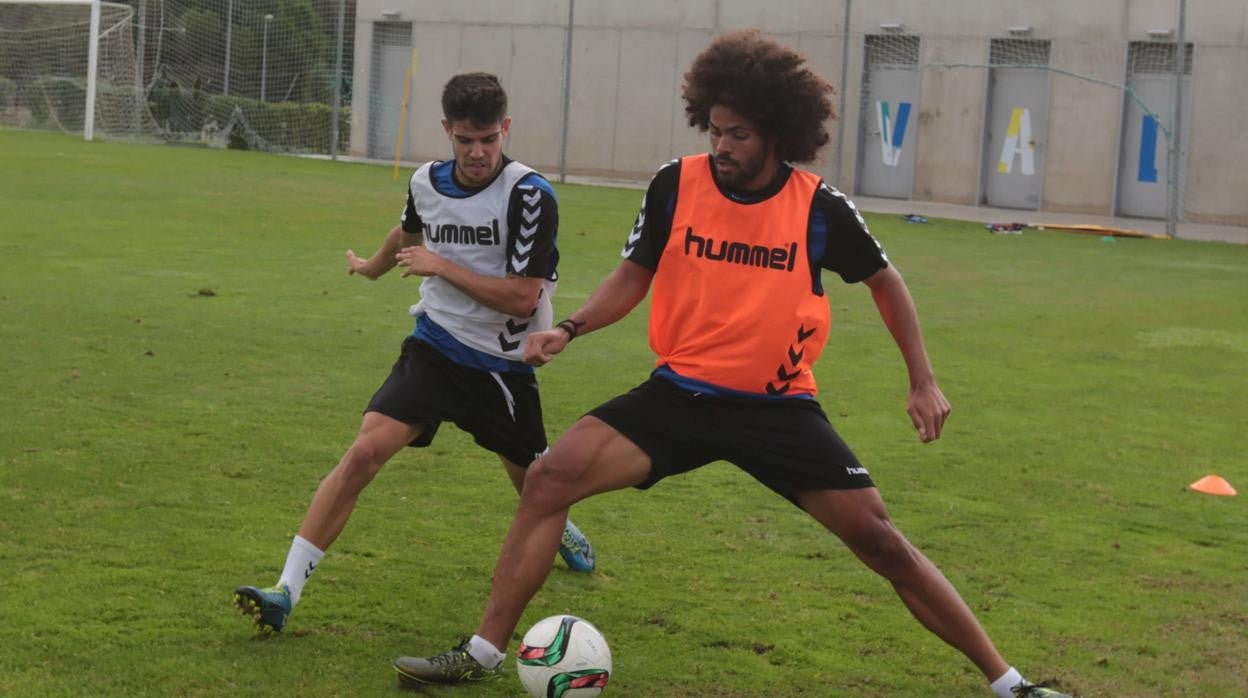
235, 72, 594, 631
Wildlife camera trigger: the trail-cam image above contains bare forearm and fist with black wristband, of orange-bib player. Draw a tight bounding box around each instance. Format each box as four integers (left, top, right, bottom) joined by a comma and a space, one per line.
524, 260, 654, 366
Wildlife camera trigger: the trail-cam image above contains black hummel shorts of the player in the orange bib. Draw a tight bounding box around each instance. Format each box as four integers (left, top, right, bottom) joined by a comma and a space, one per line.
589, 377, 875, 503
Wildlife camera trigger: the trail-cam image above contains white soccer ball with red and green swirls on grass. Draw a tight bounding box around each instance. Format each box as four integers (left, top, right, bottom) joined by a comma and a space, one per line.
515, 616, 612, 698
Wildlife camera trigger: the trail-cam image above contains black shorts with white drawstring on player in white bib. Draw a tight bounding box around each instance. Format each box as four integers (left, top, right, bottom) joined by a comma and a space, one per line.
366, 337, 547, 467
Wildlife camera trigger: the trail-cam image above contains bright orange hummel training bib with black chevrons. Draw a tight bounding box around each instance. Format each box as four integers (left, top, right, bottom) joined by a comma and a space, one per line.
650, 155, 831, 395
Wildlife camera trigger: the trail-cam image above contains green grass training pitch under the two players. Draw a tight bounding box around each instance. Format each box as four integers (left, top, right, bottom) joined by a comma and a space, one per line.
0, 130, 1248, 698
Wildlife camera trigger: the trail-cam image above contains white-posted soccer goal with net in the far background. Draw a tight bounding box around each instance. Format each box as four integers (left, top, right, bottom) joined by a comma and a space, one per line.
0, 0, 156, 140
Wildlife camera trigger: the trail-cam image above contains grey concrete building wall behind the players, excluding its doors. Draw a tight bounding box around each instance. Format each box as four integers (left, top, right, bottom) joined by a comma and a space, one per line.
351, 0, 1248, 226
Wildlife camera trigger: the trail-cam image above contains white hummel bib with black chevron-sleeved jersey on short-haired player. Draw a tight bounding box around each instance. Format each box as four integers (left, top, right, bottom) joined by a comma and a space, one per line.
402, 159, 559, 367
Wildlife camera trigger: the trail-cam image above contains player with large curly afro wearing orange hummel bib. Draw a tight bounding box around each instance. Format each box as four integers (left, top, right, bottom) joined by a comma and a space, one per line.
394, 31, 1061, 698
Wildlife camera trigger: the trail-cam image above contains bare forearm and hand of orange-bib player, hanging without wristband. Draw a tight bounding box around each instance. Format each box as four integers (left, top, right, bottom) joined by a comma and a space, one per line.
865, 265, 951, 442
